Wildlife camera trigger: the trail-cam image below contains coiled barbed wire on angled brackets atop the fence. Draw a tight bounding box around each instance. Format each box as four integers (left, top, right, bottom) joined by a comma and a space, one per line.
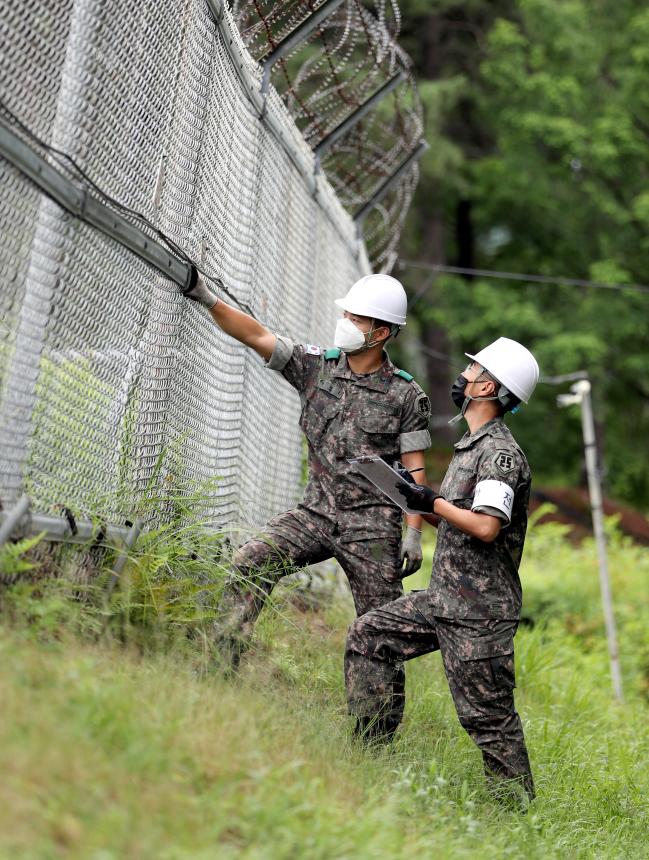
233, 0, 423, 271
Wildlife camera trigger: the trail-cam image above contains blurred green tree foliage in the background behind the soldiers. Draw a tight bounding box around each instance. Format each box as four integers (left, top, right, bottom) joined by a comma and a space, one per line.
394, 0, 649, 506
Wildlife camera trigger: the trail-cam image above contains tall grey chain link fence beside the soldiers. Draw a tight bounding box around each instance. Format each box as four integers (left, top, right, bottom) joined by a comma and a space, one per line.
0, 0, 419, 552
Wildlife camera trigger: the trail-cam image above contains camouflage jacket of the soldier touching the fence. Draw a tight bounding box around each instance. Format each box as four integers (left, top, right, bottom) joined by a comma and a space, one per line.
268, 337, 430, 537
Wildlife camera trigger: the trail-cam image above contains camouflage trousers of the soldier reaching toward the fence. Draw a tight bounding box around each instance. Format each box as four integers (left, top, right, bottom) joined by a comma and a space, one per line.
216, 508, 404, 668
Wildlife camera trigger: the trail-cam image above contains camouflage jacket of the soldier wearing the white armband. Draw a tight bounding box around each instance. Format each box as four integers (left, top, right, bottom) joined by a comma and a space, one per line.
429, 418, 531, 619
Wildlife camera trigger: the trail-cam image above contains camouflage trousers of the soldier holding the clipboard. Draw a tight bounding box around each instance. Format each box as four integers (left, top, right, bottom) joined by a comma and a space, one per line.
345, 591, 534, 799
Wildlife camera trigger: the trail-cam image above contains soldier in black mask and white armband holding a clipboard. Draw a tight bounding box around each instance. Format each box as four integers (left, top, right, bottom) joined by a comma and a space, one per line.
345, 338, 538, 799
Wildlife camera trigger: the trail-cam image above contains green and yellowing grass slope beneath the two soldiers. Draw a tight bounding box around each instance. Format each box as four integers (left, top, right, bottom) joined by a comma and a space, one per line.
0, 512, 649, 860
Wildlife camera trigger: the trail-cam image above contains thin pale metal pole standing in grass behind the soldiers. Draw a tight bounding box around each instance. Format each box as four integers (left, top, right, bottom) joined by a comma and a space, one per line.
557, 379, 624, 702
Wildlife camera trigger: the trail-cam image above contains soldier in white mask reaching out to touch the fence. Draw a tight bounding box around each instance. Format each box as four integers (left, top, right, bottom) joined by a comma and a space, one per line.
182, 268, 430, 664
